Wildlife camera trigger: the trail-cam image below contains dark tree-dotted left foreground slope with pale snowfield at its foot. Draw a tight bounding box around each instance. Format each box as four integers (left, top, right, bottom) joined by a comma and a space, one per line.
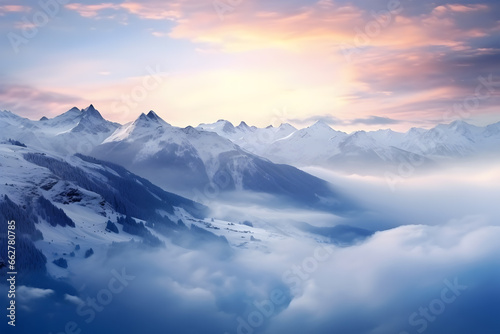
0, 144, 360, 288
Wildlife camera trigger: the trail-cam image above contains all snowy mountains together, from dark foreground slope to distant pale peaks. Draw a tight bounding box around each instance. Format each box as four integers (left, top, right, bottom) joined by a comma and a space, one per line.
0, 105, 500, 332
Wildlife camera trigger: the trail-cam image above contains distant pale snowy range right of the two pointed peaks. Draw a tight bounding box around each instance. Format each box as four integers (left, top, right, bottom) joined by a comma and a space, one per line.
199, 120, 500, 174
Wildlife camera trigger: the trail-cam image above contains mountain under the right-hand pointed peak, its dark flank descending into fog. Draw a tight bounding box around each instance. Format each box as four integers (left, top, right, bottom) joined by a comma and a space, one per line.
91, 112, 347, 210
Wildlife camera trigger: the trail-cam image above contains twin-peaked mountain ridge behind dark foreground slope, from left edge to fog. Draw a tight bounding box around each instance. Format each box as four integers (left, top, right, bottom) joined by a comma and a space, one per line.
0, 105, 360, 212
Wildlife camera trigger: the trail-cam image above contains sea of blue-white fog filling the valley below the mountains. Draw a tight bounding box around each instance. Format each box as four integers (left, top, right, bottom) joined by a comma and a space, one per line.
4, 163, 500, 334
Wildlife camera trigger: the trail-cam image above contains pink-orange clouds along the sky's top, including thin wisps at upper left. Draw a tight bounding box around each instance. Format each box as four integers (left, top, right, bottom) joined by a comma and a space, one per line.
63, 0, 498, 53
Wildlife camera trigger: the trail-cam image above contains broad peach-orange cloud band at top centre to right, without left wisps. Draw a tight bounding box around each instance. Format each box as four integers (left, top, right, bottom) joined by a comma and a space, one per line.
170, 0, 492, 52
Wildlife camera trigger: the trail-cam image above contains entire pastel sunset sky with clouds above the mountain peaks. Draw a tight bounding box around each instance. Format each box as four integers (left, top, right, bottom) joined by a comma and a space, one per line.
0, 0, 500, 131
